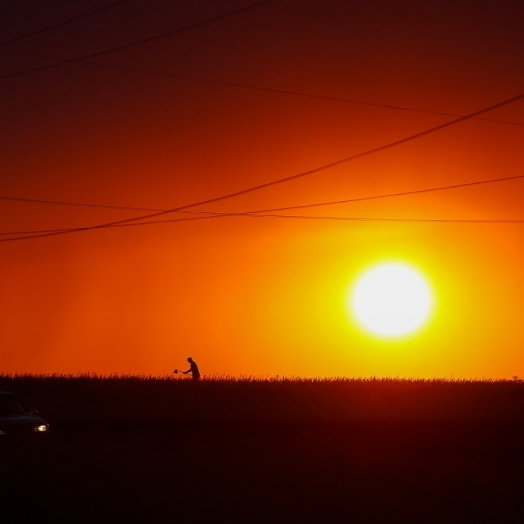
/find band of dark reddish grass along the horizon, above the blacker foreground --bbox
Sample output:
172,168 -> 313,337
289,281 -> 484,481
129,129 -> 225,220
0,374 -> 524,423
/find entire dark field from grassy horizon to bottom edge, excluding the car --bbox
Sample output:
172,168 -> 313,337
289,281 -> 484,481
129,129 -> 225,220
0,375 -> 524,524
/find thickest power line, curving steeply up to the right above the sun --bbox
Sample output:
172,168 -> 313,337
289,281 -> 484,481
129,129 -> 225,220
2,93 -> 524,241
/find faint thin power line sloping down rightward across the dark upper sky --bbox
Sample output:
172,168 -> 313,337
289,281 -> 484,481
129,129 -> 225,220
4,49 -> 524,126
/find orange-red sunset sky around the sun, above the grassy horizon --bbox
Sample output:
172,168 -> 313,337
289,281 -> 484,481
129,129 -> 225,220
0,0 -> 524,378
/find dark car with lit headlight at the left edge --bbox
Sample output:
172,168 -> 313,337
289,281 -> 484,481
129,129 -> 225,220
0,391 -> 49,439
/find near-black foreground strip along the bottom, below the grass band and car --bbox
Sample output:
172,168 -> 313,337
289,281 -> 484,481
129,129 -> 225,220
0,421 -> 524,524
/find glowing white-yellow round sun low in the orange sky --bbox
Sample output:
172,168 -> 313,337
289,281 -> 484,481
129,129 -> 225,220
347,262 -> 433,338
